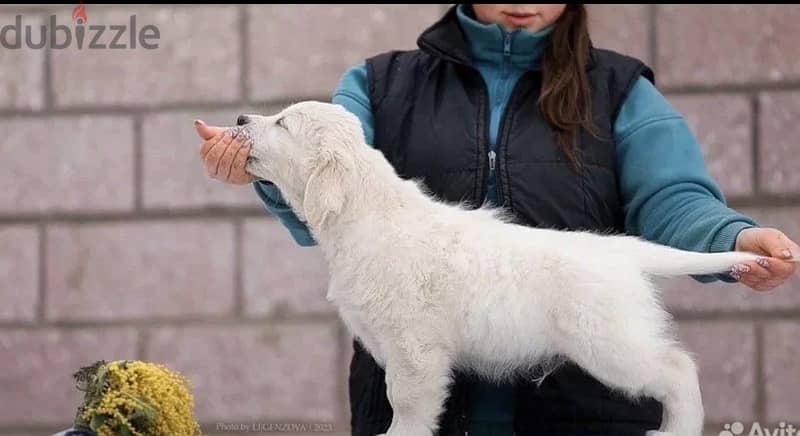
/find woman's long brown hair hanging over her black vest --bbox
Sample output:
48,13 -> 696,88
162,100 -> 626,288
538,4 -> 596,168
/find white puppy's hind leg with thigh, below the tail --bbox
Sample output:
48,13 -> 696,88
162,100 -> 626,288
559,290 -> 703,436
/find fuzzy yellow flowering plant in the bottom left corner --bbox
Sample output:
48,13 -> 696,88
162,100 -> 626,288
74,360 -> 200,436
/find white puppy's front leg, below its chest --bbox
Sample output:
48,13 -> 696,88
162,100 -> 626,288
378,344 -> 451,436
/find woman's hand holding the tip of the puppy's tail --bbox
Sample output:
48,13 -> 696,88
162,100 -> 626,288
731,228 -> 800,291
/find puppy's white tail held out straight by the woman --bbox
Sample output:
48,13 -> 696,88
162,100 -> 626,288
633,240 -> 763,277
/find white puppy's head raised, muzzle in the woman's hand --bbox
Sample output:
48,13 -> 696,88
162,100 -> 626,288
237,101 -> 364,230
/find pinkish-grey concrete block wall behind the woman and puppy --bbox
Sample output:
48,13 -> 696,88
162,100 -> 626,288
0,4 -> 800,436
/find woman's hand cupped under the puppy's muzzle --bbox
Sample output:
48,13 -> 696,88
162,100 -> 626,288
194,120 -> 257,185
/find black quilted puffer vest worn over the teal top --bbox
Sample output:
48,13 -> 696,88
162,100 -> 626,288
349,6 -> 662,436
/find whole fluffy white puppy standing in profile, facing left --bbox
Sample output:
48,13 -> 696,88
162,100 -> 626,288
241,102 -> 759,436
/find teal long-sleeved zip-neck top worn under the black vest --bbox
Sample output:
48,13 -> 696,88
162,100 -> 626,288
255,5 -> 757,426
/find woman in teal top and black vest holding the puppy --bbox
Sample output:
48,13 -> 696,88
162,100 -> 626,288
197,4 -> 800,436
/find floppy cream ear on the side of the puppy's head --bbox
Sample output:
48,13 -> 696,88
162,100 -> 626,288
303,147 -> 352,228
